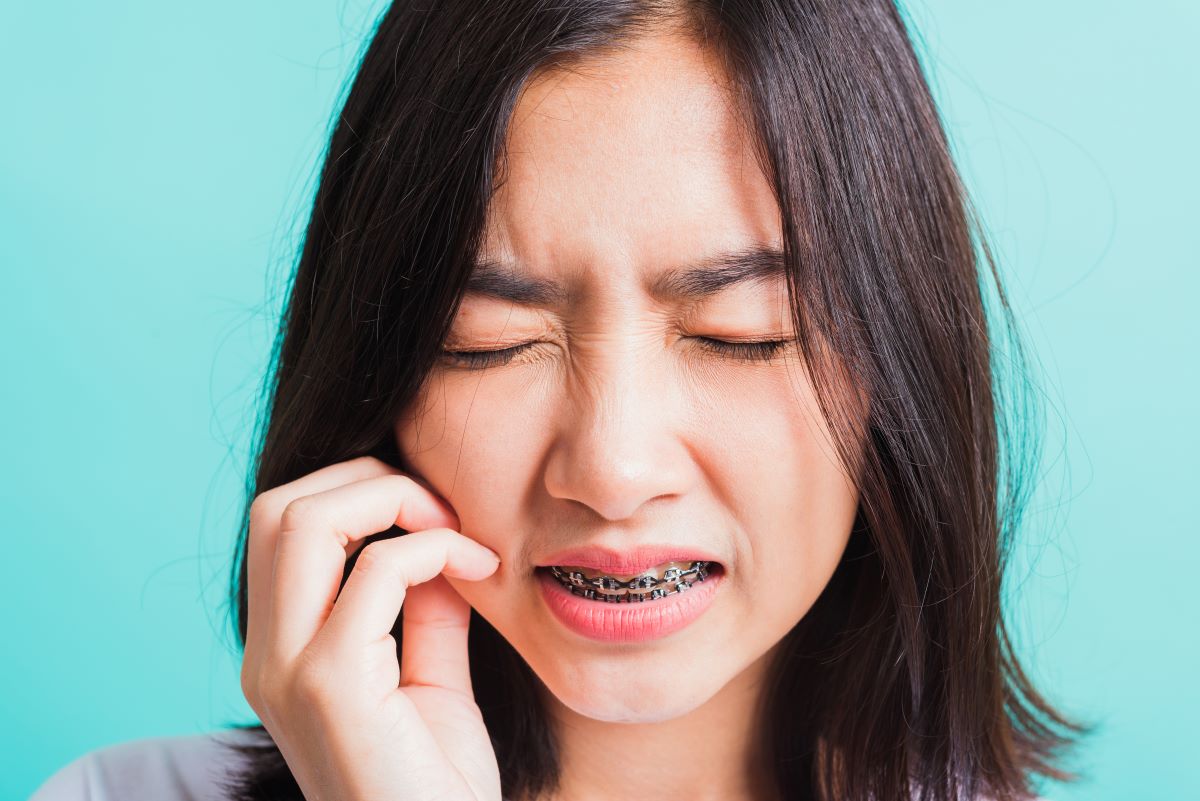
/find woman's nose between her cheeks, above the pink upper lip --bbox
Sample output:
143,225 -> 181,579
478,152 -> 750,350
545,349 -> 696,520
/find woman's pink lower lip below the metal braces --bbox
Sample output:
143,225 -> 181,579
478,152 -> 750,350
535,567 -> 725,643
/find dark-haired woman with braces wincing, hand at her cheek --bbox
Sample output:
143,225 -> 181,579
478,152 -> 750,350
35,0 -> 1084,801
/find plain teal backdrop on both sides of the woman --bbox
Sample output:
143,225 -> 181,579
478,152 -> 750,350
0,0 -> 1200,801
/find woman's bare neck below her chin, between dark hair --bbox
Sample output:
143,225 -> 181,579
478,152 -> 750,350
530,646 -> 778,801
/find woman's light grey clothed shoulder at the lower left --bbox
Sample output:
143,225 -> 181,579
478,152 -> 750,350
29,729 -> 261,801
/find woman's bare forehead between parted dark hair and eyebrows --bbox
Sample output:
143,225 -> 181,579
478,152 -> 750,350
480,27 -> 780,299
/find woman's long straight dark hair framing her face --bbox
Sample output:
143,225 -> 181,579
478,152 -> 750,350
223,0 -> 1087,801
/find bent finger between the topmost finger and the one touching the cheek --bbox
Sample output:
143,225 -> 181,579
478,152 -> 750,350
268,475 -> 466,661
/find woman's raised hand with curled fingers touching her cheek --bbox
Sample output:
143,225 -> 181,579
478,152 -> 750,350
241,457 -> 500,801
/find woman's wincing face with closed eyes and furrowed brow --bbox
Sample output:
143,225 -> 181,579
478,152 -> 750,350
396,36 -> 857,722
